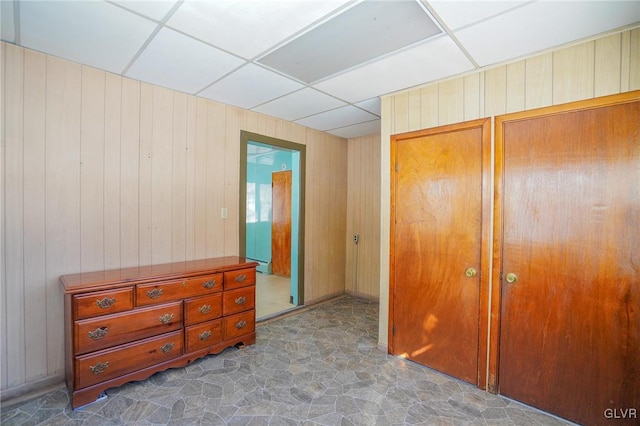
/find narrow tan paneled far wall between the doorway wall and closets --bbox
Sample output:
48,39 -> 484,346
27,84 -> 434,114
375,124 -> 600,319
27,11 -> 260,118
346,135 -> 380,300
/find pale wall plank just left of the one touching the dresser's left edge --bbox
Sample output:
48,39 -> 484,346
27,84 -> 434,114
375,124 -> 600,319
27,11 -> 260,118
22,50 -> 47,381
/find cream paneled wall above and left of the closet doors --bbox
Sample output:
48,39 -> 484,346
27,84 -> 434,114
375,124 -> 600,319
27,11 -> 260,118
378,28 -> 640,348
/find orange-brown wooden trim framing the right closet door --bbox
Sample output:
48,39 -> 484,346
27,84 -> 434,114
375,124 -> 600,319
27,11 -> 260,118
487,90 -> 640,393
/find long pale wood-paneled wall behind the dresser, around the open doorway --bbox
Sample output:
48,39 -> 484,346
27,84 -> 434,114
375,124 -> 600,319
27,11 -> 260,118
0,43 -> 348,398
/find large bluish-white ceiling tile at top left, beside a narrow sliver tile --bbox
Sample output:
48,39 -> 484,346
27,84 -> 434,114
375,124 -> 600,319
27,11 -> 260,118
20,1 -> 156,73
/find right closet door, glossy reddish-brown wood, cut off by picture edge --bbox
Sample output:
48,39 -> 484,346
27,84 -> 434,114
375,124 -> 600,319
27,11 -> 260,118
496,97 -> 640,425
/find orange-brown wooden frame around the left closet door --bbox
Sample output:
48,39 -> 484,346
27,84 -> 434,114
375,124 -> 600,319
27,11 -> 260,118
387,118 -> 493,389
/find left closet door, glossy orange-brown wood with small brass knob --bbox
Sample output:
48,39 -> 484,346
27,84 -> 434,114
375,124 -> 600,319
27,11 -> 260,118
390,121 -> 489,387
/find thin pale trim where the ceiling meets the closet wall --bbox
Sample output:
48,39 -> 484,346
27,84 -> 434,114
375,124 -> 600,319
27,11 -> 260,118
380,21 -> 640,103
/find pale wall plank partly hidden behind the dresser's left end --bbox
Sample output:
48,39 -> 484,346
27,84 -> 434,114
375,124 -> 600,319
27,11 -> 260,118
44,56 -> 82,375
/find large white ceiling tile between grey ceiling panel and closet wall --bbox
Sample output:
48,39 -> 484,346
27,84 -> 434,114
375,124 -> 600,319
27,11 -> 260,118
314,36 -> 473,102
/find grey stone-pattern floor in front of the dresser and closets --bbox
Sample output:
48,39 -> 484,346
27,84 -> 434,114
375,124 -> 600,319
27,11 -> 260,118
0,297 -> 571,426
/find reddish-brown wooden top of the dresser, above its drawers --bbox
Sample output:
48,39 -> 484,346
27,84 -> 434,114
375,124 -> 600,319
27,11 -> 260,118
60,256 -> 258,294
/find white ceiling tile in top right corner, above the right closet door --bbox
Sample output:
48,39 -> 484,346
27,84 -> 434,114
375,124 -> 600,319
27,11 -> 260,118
455,1 -> 640,66
